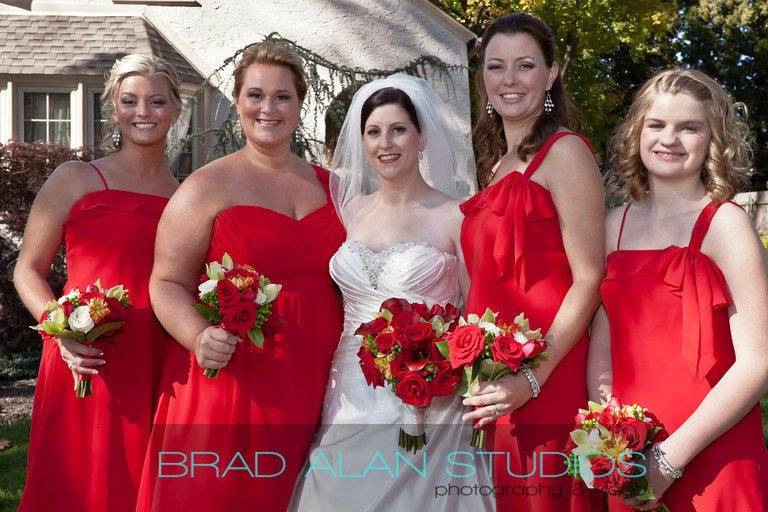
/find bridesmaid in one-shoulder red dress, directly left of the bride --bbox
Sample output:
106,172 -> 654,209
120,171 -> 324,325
137,42 -> 345,512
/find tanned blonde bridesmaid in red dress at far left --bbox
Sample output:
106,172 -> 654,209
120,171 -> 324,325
14,54 -> 181,512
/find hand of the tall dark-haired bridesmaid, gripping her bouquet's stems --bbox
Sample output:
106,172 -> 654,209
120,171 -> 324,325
462,374 -> 531,428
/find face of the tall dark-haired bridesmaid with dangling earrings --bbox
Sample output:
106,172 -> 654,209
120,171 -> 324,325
483,32 -> 559,121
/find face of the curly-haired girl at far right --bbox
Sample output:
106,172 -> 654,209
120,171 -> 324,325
640,93 -> 712,184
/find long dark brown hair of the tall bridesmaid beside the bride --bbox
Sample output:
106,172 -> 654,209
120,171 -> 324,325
473,13 -> 578,185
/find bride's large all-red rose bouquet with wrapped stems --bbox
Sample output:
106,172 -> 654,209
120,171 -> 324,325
355,298 -> 460,452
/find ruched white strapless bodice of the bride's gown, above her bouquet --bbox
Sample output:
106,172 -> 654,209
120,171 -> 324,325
329,240 -> 460,336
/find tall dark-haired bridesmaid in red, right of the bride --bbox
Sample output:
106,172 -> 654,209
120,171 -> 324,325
461,14 -> 603,511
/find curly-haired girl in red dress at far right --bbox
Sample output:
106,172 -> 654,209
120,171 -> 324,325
590,69 -> 768,512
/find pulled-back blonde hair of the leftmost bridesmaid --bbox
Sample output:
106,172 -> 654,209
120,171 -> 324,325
101,53 -> 181,151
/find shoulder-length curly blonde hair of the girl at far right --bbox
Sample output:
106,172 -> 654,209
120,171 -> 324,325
611,68 -> 752,201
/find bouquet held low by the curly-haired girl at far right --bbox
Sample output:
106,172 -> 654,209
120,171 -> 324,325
565,396 -> 669,512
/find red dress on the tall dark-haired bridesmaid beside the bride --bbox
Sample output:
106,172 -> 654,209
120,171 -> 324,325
461,131 -> 601,511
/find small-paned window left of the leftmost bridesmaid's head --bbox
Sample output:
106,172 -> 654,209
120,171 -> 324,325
22,91 -> 72,146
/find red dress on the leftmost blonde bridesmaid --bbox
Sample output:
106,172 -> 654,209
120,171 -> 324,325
19,164 -> 170,512
